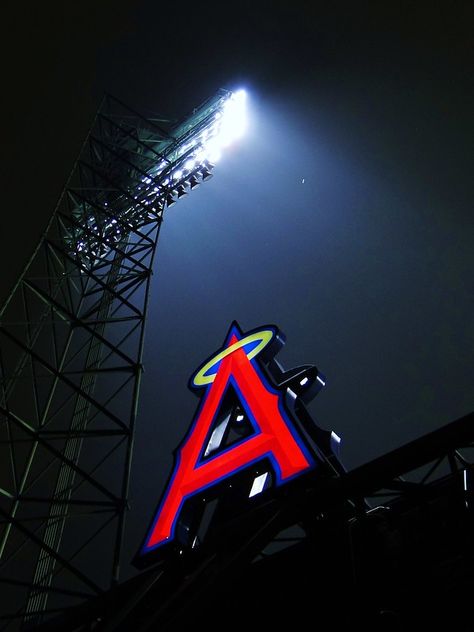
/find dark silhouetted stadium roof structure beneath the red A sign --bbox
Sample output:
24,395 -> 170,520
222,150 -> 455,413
28,414 -> 474,632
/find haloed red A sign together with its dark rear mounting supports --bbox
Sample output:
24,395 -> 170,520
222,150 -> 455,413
136,322 -> 335,564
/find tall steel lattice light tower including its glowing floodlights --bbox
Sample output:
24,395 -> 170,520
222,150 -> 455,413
0,90 -> 246,630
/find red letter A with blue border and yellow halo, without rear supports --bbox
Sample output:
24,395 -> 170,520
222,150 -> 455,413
140,323 -> 323,556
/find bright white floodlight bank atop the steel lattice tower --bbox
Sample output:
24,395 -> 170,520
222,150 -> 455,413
70,90 -> 246,264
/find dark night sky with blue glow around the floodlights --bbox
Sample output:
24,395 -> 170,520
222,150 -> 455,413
0,0 -> 474,576
